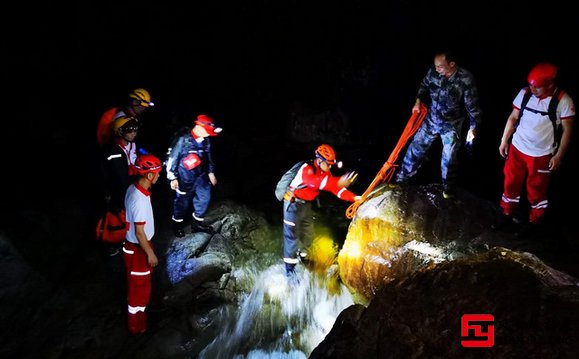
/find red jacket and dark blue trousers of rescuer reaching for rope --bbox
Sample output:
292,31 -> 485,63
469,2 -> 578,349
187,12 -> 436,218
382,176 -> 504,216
283,162 -> 355,274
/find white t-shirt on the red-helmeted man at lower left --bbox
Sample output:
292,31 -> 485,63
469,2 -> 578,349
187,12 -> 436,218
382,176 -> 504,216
125,183 -> 155,244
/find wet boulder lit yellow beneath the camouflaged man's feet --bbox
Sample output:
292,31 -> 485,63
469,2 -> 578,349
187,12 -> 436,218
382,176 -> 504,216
338,185 -> 496,302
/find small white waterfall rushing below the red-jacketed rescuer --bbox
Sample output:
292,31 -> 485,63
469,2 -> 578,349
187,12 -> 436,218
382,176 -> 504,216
198,265 -> 354,359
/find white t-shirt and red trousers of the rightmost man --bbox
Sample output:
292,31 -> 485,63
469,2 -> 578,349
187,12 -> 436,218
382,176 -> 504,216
500,88 -> 575,223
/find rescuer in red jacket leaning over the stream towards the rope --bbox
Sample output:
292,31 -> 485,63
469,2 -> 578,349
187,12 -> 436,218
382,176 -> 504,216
283,144 -> 360,277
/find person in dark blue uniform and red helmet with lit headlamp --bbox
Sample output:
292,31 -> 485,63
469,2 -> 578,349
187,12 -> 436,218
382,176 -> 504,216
166,115 -> 222,238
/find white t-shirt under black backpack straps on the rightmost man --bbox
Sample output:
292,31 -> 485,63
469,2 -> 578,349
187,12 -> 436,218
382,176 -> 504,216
513,88 -> 575,157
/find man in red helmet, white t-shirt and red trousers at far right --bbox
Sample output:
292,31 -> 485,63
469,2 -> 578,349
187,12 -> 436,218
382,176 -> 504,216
492,63 -> 575,238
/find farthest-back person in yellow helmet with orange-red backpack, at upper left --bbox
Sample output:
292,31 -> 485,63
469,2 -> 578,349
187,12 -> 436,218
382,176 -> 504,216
97,88 -> 155,146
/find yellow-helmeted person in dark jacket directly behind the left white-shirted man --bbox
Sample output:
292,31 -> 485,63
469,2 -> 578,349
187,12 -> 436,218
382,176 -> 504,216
103,116 -> 139,257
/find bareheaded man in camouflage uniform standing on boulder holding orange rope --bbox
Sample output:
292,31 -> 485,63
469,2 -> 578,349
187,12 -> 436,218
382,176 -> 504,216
396,52 -> 481,198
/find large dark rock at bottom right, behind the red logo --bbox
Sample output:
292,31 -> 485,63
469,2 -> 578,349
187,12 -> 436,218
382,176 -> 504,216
310,247 -> 579,359
